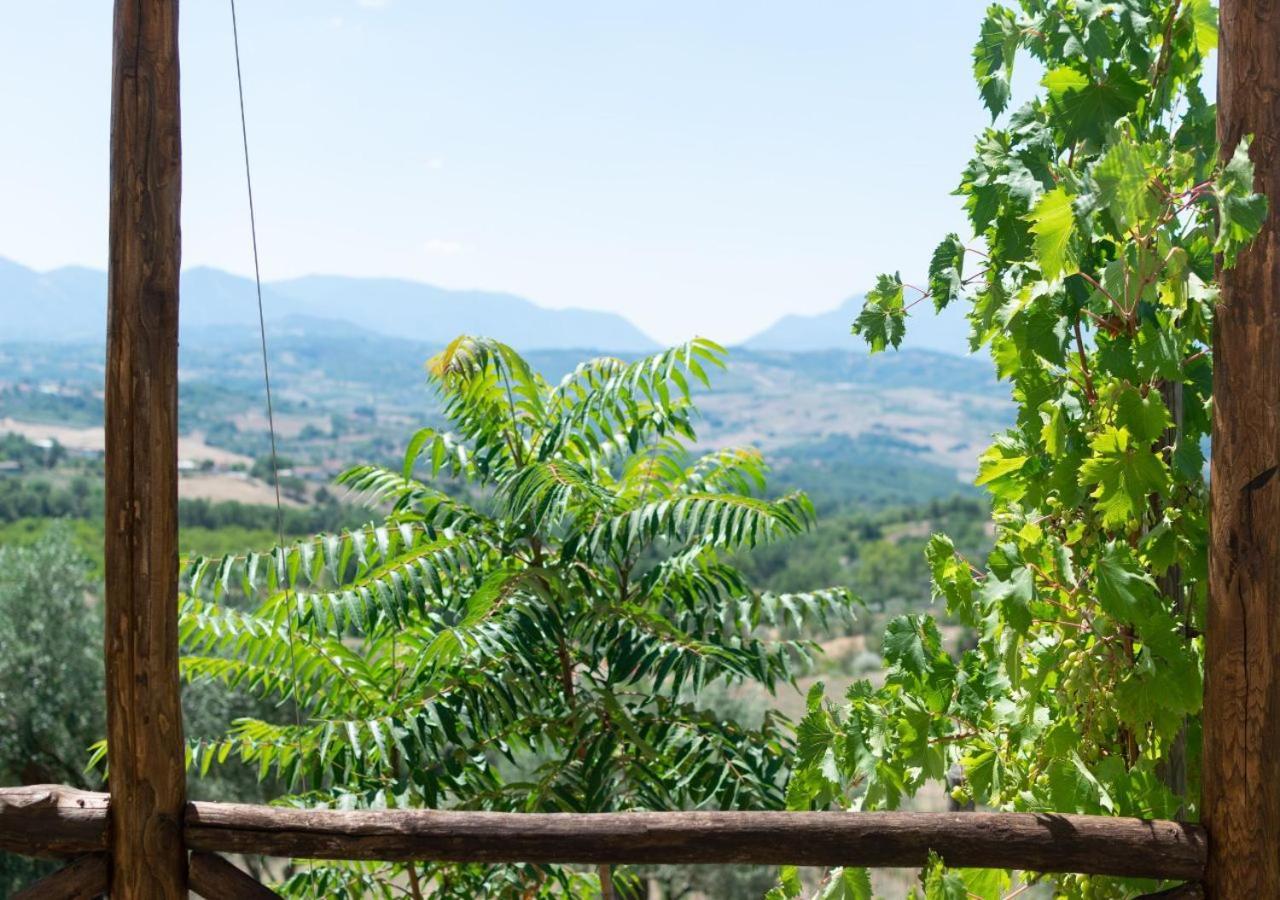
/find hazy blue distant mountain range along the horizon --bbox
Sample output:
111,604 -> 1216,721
0,259 -> 968,353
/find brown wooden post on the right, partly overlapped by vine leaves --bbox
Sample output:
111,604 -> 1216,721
1202,0 -> 1280,900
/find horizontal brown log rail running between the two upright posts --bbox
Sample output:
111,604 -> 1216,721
0,787 -> 1207,880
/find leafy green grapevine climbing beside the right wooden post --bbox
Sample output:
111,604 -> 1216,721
785,0 -> 1266,897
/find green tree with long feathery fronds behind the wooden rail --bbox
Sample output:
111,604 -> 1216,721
172,338 -> 850,897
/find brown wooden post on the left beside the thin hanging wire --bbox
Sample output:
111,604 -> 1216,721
106,0 -> 187,900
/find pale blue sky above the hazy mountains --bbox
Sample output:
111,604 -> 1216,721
0,0 -> 1003,341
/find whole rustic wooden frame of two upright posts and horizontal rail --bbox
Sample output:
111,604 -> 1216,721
0,0 -> 1280,900
